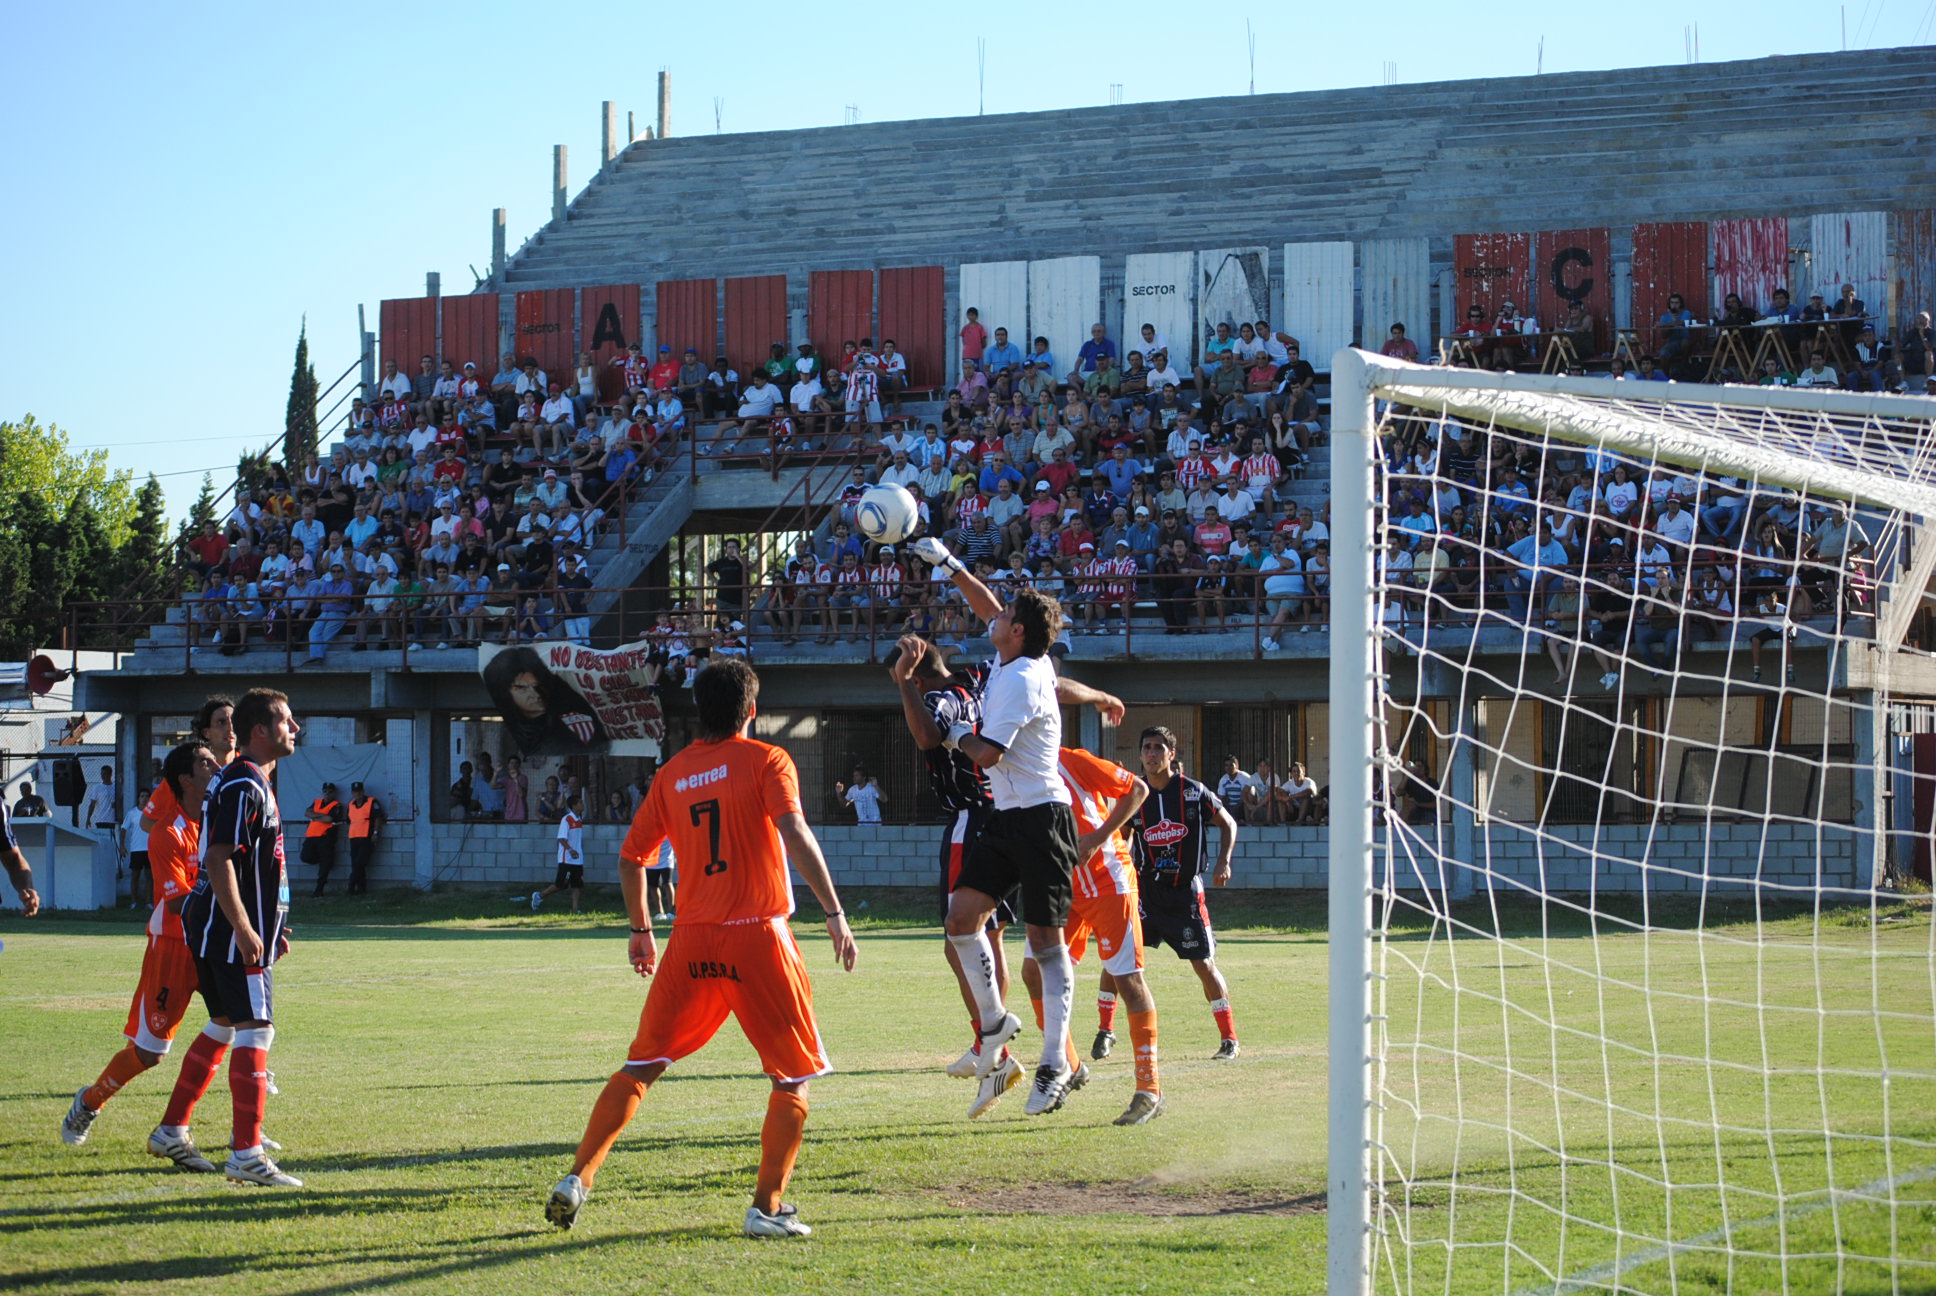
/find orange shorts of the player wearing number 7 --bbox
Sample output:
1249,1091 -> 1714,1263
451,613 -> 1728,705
625,918 -> 832,1081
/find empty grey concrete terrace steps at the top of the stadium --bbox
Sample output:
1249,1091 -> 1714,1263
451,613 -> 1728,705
498,46 -> 1936,296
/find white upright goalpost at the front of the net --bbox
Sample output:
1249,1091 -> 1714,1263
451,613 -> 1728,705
1326,349 -> 1380,1296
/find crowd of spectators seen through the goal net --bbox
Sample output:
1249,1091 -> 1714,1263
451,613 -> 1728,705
1376,409 -> 1872,688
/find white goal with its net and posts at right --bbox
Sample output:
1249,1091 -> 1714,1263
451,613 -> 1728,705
1330,353 -> 1936,1292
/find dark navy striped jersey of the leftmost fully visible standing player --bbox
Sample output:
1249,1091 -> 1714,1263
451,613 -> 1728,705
182,757 -> 288,967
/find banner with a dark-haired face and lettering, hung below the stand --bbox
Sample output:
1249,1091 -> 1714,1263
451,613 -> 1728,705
478,641 -> 666,757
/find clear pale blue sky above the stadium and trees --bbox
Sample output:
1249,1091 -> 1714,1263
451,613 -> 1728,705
0,0 -> 1936,513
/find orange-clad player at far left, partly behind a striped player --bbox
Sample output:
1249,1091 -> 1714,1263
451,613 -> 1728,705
60,742 -> 219,1172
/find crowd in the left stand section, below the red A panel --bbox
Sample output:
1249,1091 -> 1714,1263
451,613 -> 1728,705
182,355 -> 680,663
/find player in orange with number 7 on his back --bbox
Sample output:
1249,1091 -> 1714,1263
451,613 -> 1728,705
544,657 -> 856,1238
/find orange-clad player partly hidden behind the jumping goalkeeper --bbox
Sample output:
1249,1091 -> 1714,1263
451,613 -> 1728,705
1045,748 -> 1164,1126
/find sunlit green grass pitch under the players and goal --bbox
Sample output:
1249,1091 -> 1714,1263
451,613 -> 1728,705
0,893 -> 1936,1294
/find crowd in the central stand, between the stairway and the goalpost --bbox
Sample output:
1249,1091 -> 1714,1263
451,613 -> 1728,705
673,310 -> 1328,647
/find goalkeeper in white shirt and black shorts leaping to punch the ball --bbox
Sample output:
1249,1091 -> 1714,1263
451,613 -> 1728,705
910,537 -> 1078,1116
